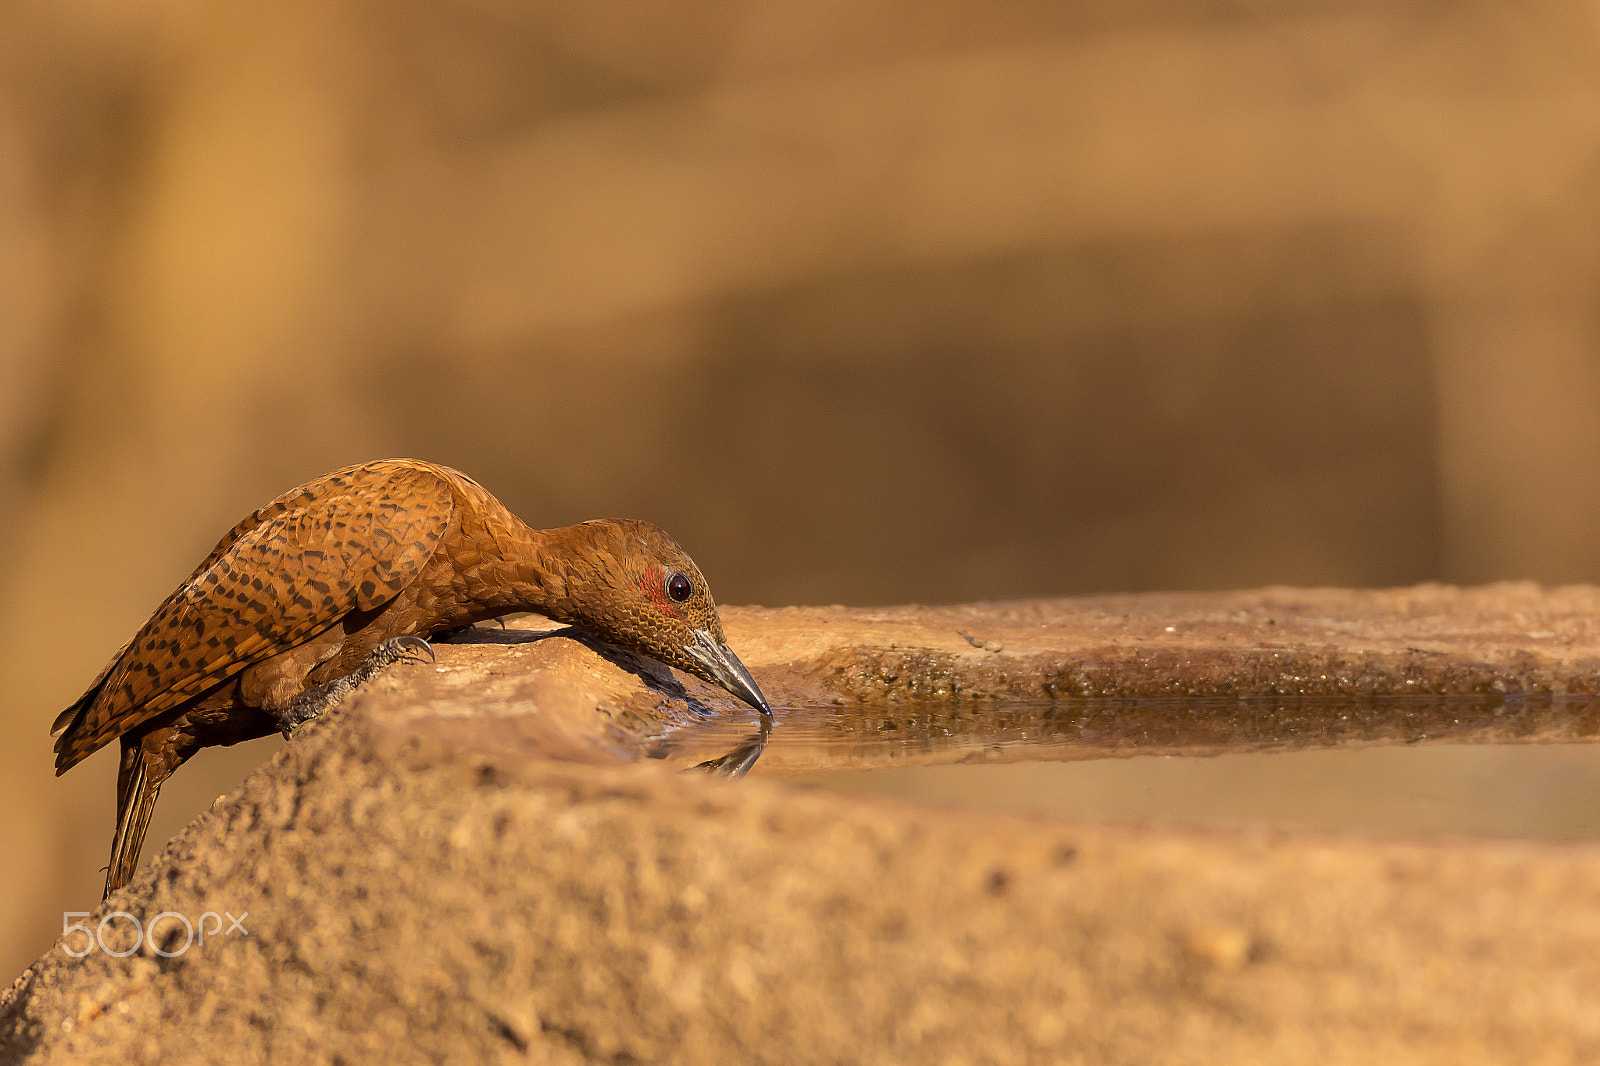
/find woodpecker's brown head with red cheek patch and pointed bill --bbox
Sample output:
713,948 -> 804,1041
552,519 -> 771,714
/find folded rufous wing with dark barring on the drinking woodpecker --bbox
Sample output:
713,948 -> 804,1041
56,463 -> 454,773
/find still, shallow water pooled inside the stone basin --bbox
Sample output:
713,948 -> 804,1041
651,698 -> 1600,840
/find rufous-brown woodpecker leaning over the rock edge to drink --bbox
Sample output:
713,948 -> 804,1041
51,459 -> 770,895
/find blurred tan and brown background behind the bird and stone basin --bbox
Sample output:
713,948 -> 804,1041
0,0 -> 1600,975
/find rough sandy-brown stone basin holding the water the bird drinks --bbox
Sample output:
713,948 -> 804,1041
0,586 -> 1600,1064
